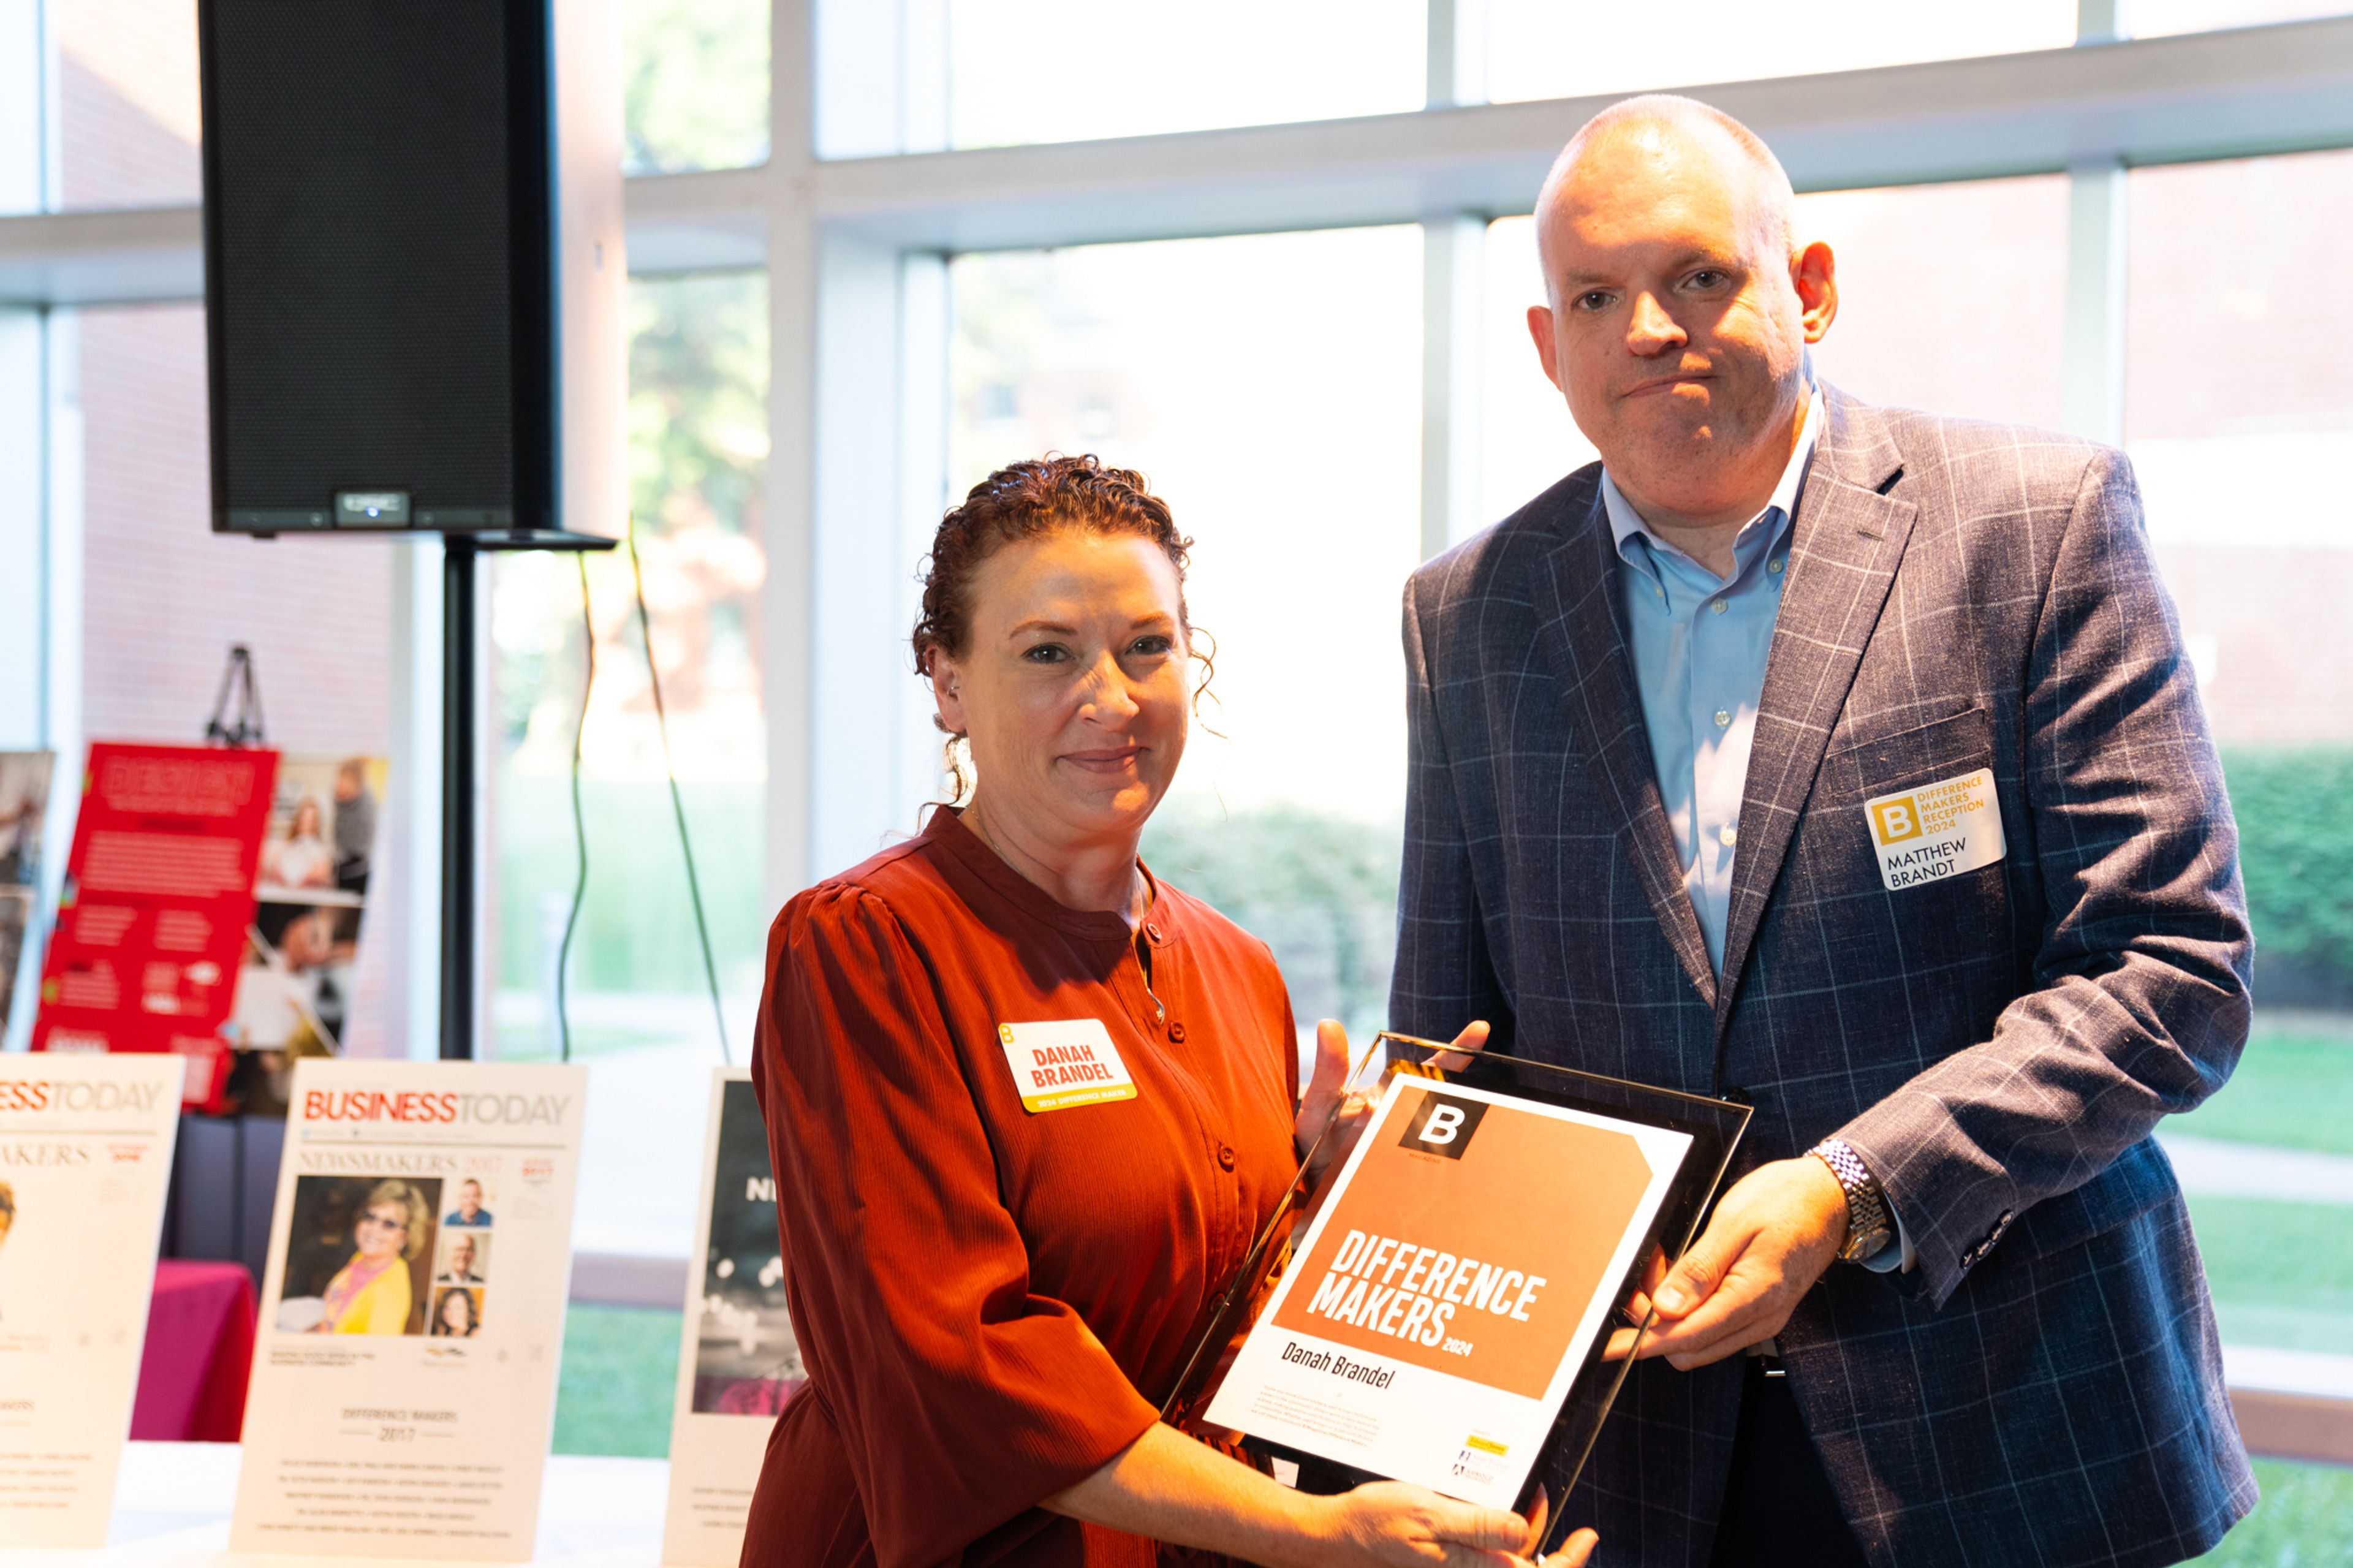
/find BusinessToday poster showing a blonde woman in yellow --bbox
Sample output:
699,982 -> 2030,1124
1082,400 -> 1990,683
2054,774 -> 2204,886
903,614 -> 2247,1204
228,1057 -> 588,1561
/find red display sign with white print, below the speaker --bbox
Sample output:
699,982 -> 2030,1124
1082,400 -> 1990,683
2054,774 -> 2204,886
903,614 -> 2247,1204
33,741 -> 278,1104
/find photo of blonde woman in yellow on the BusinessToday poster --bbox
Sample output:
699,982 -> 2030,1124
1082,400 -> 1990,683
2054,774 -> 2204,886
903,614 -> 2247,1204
271,1177 -> 445,1335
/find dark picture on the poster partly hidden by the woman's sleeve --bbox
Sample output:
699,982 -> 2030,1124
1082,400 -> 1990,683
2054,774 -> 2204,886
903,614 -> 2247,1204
694,1083 -> 809,1417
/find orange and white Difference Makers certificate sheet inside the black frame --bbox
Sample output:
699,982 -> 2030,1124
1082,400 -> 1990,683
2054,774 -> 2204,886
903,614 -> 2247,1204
1207,1076 -> 1692,1507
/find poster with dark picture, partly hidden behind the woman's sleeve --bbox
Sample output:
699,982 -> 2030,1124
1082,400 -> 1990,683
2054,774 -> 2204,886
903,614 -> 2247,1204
661,1067 -> 807,1568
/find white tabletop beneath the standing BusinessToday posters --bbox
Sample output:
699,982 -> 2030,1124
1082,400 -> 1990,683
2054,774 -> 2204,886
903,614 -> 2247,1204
0,1443 -> 670,1568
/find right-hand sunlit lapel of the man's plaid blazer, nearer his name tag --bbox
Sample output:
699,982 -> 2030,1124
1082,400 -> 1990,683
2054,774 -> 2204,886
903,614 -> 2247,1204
1715,388 -> 1913,1031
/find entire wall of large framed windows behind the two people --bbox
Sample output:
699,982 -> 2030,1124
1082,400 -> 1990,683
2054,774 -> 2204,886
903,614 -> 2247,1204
13,0 -> 2353,1525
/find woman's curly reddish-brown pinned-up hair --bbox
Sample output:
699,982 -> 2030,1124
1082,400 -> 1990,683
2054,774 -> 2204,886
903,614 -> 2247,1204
911,452 -> 1210,800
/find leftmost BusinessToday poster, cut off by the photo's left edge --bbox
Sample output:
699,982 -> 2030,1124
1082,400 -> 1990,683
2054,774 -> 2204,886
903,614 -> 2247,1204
0,1053 -> 186,1547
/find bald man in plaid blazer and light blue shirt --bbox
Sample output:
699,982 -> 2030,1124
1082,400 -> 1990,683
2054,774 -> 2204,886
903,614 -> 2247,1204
1390,97 -> 2254,1568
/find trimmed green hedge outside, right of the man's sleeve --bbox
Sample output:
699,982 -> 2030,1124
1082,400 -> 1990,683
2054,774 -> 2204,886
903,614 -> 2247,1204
2224,746 -> 2353,993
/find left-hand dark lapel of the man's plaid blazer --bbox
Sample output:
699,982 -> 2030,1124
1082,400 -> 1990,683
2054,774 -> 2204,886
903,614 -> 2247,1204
1537,485 -> 1715,1008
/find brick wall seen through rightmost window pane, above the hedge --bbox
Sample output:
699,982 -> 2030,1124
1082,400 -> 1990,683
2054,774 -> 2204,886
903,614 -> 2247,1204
2125,151 -> 2353,746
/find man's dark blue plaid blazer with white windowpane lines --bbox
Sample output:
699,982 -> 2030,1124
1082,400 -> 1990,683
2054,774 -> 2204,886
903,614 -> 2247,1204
1390,391 -> 2254,1568
